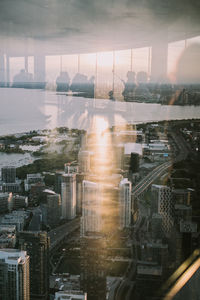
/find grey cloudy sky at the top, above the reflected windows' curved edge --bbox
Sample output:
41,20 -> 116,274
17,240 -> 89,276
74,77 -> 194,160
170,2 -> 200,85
0,0 -> 200,53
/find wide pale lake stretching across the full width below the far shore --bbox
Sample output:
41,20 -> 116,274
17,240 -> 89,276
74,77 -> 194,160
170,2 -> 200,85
0,88 -> 200,135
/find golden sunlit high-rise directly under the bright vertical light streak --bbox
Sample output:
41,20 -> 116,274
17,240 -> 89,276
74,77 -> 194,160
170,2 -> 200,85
81,180 -> 102,236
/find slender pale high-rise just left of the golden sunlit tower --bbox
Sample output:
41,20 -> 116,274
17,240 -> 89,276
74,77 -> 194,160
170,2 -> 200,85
61,174 -> 76,220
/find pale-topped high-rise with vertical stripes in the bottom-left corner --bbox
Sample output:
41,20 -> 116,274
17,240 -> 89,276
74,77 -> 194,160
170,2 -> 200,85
0,249 -> 30,300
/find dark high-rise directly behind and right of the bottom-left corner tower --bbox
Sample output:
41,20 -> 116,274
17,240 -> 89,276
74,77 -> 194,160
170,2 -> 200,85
18,231 -> 50,300
